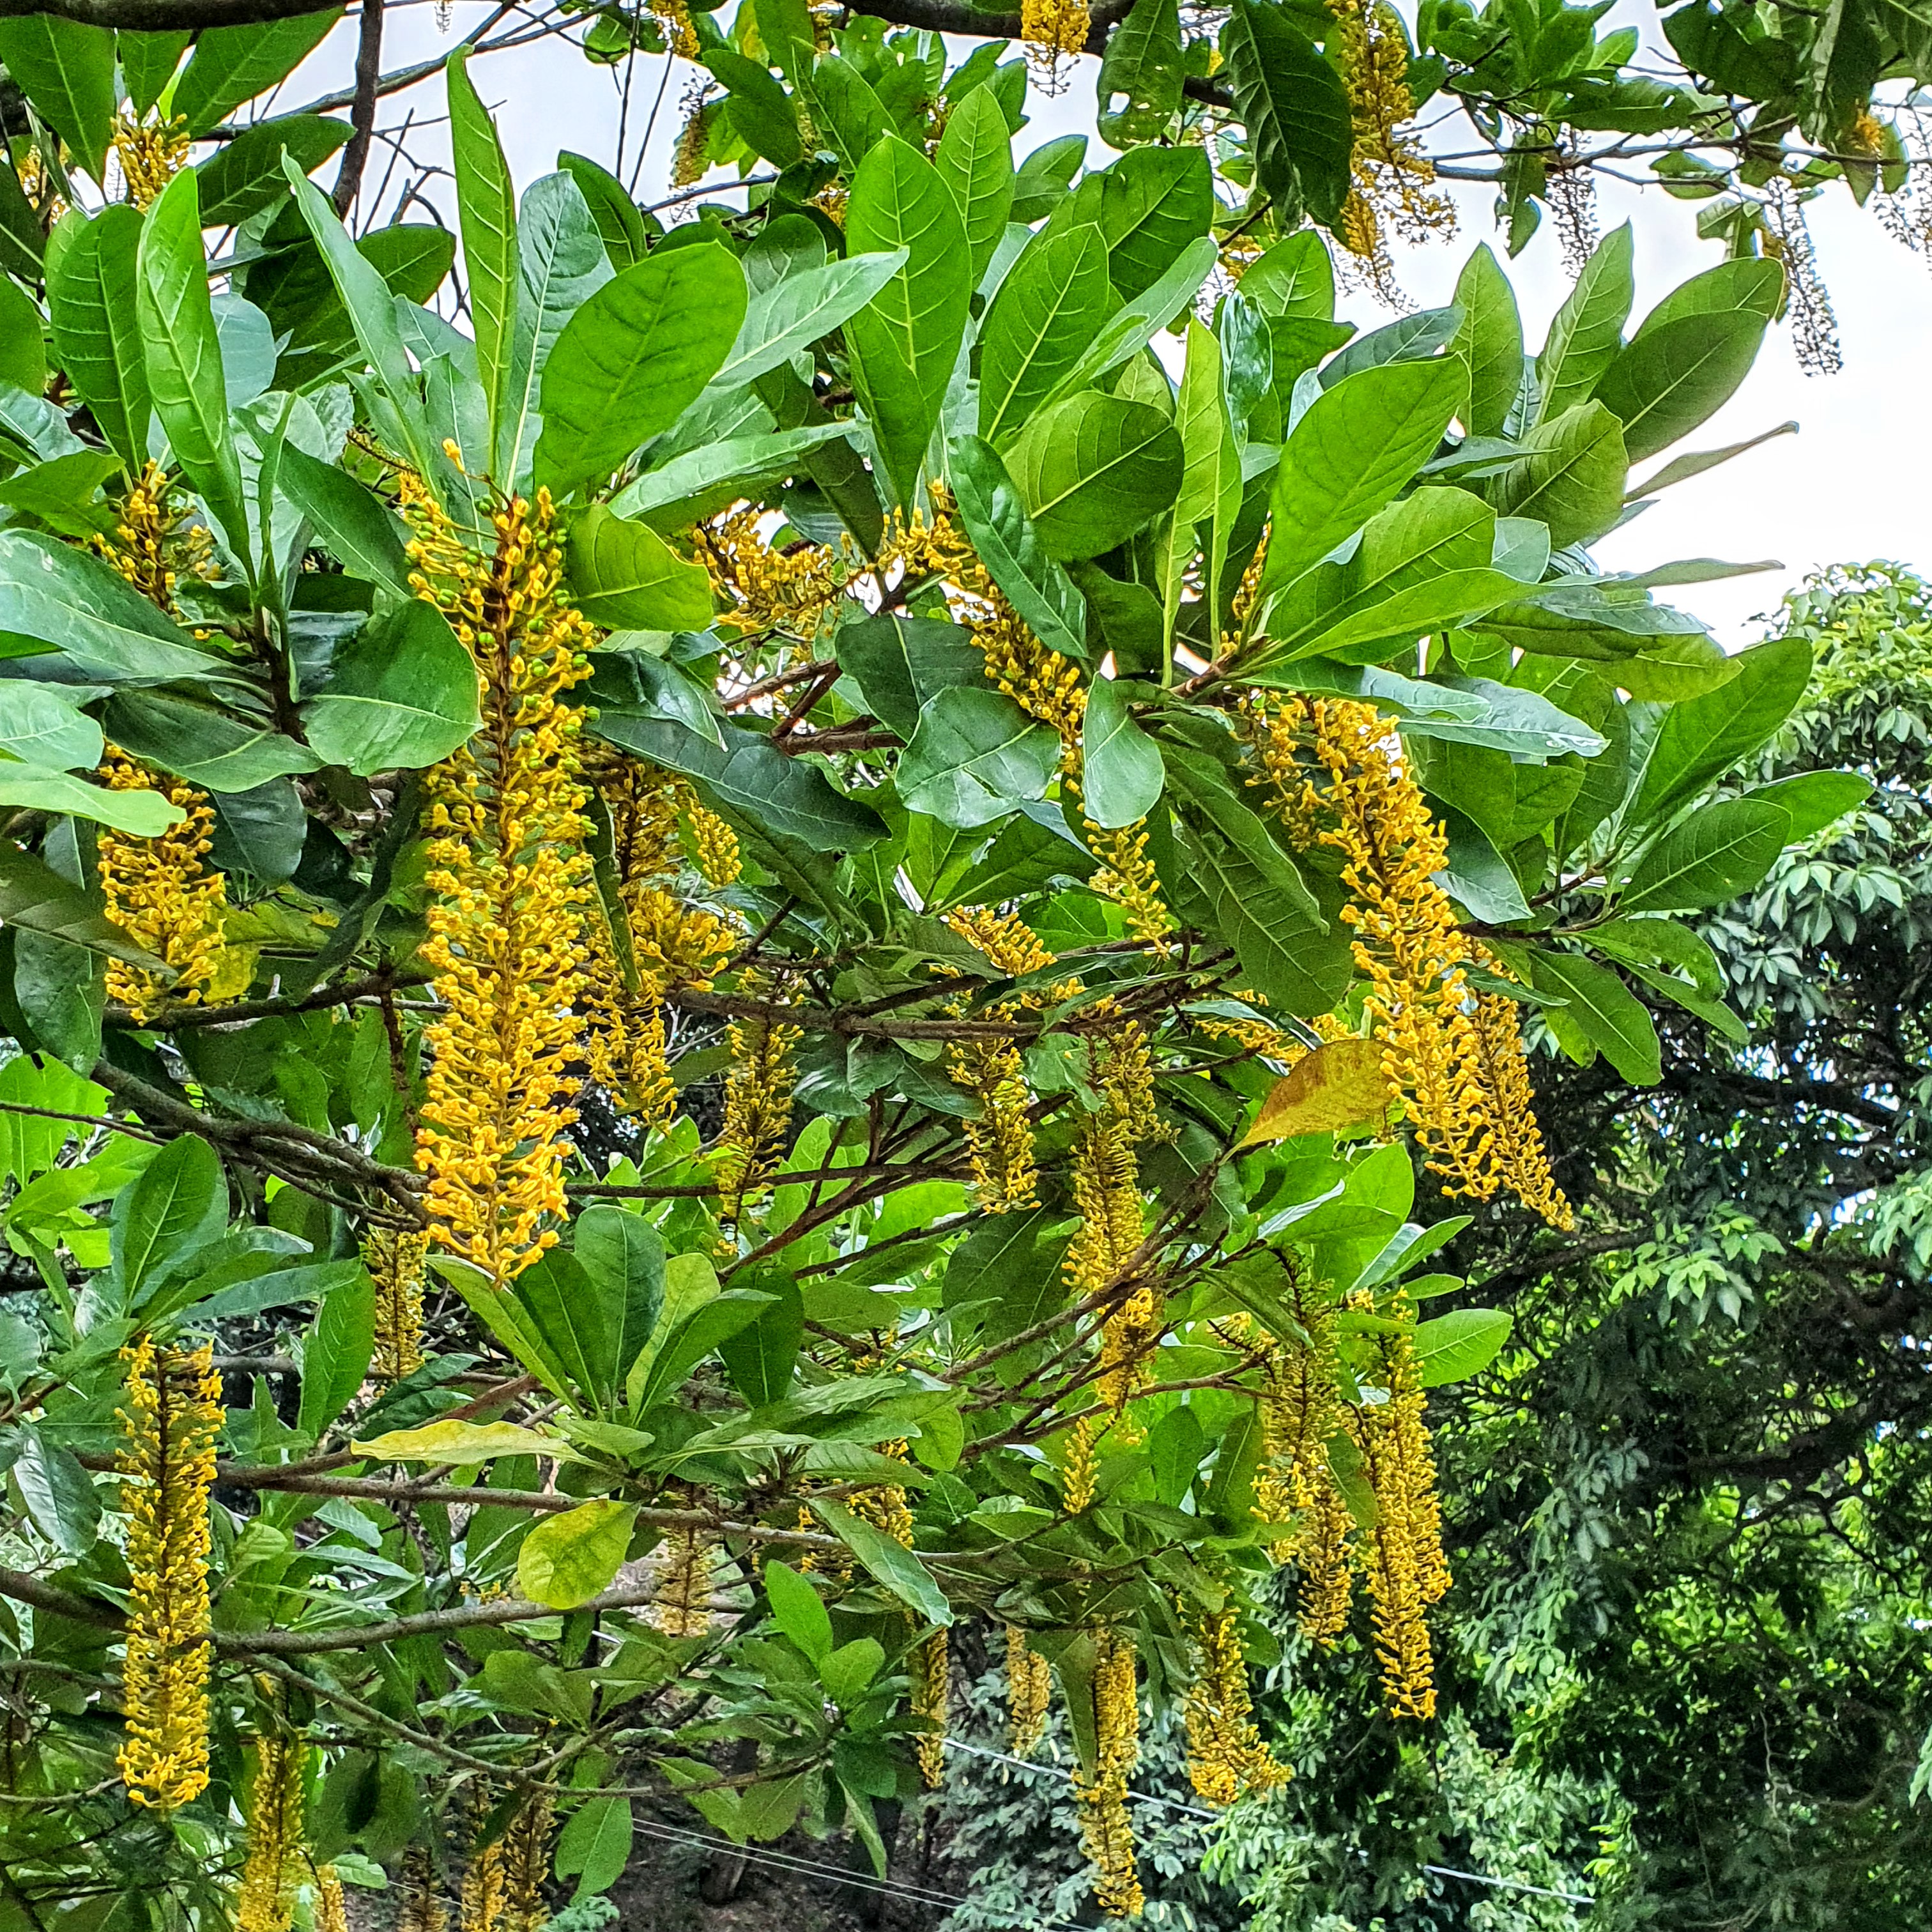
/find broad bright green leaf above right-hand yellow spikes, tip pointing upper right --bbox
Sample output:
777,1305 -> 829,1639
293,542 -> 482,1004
1246,359 -> 1460,601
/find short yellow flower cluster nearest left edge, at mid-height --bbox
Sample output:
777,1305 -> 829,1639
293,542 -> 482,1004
95,746 -> 228,1020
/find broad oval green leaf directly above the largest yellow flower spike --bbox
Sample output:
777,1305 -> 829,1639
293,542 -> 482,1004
537,243 -> 746,491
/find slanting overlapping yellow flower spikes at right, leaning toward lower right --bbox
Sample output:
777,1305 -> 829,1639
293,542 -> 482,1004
1248,698 -> 1573,1227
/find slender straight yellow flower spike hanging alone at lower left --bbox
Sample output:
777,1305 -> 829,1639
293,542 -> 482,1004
118,1335 -> 226,1813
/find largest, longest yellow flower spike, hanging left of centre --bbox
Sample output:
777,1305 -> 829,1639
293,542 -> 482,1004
406,491 -> 591,1285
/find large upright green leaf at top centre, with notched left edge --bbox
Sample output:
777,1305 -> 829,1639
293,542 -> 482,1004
847,135 -> 972,506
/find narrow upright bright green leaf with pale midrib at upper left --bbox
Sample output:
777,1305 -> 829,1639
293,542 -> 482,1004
135,172 -> 249,564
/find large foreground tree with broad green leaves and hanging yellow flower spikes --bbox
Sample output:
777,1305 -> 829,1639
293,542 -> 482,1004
0,15 -> 1837,1928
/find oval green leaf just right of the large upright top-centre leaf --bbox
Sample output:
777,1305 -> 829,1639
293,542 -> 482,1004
979,222 -> 1115,448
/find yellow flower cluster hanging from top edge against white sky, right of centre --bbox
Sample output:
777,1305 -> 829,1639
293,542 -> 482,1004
1327,0 -> 1455,307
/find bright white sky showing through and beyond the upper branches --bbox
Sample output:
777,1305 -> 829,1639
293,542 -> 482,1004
274,0 -> 1932,647
